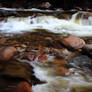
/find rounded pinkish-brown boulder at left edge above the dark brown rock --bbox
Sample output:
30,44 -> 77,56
0,46 -> 17,61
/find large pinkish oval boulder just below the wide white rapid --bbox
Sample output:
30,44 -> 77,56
61,35 -> 85,49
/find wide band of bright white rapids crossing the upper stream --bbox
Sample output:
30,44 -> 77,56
0,13 -> 92,36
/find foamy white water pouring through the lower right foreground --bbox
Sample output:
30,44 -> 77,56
31,63 -> 92,92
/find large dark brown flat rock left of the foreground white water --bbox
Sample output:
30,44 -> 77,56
0,61 -> 33,82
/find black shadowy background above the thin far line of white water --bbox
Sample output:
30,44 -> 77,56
0,0 -> 92,9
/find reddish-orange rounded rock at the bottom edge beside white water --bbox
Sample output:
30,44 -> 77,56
16,82 -> 32,92
